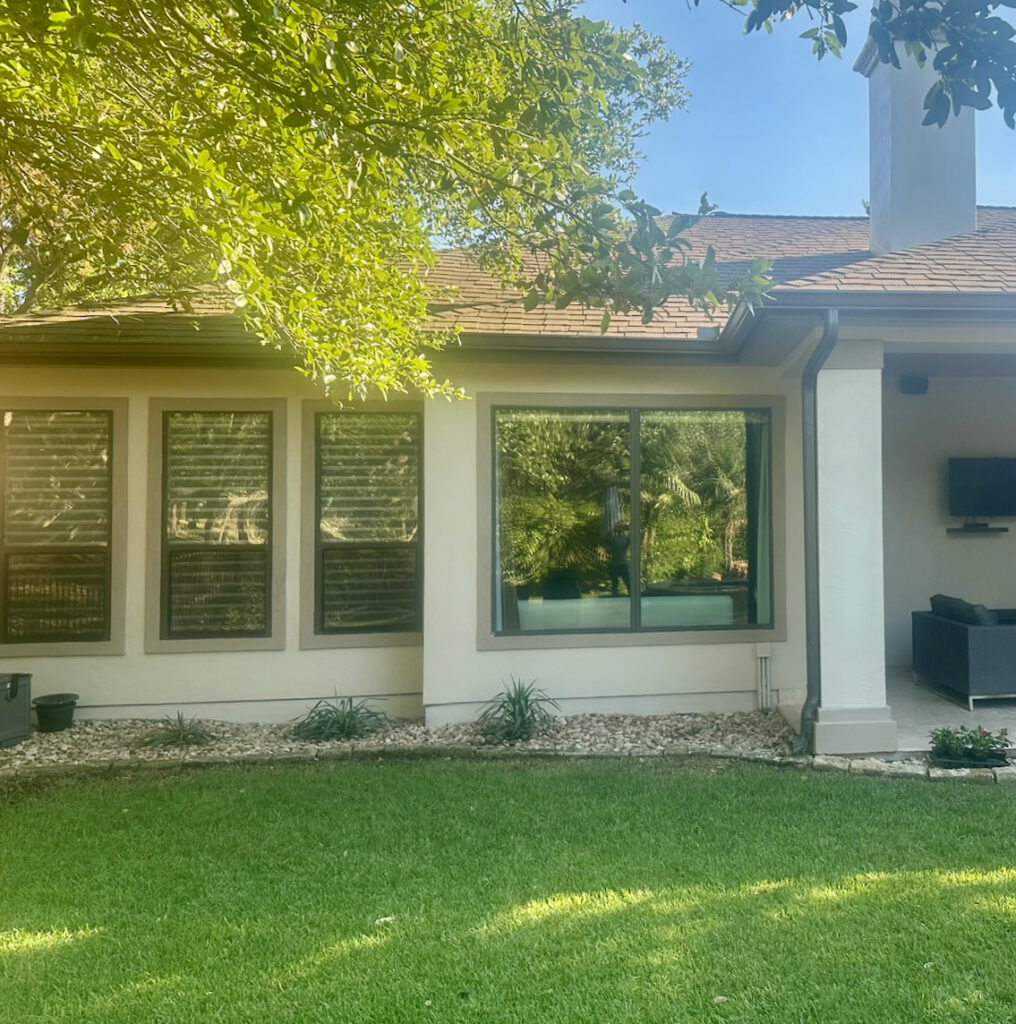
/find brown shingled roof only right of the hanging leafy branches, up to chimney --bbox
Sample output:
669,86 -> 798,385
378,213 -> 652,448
428,207 -> 1016,339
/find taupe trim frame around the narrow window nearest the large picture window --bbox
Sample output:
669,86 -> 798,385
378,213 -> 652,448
300,398 -> 426,650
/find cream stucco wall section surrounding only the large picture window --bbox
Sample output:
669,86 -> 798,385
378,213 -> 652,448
415,359 -> 805,724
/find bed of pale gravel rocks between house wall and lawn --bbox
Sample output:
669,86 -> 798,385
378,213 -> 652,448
0,712 -> 794,773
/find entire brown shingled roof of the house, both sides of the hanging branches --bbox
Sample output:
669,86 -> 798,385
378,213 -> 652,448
0,207 -> 1016,356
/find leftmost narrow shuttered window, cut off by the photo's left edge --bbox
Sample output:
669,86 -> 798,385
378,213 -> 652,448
0,409 -> 113,643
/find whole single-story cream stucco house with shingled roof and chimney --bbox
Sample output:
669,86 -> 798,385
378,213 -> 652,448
0,46 -> 1016,753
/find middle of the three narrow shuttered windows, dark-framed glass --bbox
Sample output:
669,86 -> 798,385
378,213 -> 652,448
162,411 -> 272,639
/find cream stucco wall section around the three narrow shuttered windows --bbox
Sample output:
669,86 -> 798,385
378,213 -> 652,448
0,368 -> 421,721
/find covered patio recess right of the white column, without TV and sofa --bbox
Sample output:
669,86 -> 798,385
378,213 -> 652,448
882,352 -> 1016,751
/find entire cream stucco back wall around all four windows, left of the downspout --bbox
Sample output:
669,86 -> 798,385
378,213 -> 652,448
0,355 -> 805,723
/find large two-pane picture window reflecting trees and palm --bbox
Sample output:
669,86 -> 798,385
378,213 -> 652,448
493,408 -> 772,634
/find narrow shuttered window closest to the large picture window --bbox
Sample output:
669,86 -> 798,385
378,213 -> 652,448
314,413 -> 422,634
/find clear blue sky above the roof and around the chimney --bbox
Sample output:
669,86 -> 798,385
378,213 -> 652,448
583,0 -> 1016,215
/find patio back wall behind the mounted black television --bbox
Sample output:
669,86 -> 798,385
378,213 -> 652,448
883,376 -> 1016,666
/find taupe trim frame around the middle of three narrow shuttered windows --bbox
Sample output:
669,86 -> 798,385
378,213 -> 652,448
144,398 -> 287,654
